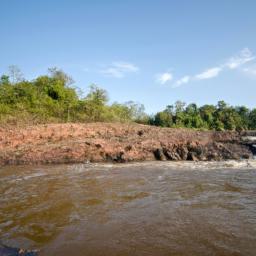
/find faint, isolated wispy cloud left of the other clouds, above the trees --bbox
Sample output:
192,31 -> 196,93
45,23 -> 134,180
100,61 -> 139,78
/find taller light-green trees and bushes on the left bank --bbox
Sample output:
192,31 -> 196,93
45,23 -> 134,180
0,66 -> 146,124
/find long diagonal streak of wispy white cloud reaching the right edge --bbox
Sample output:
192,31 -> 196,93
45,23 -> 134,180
172,48 -> 256,87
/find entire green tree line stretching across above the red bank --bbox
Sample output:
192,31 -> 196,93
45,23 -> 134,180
0,66 -> 256,130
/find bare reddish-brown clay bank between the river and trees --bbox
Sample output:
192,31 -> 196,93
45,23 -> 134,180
0,123 -> 252,165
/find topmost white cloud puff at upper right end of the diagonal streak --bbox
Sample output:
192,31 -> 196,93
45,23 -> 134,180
226,48 -> 255,69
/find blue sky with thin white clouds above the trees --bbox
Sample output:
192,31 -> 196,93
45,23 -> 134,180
0,0 -> 256,113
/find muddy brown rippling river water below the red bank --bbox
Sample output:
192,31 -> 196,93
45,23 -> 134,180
0,161 -> 256,256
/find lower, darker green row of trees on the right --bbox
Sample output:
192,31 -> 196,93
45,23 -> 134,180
149,101 -> 256,131
